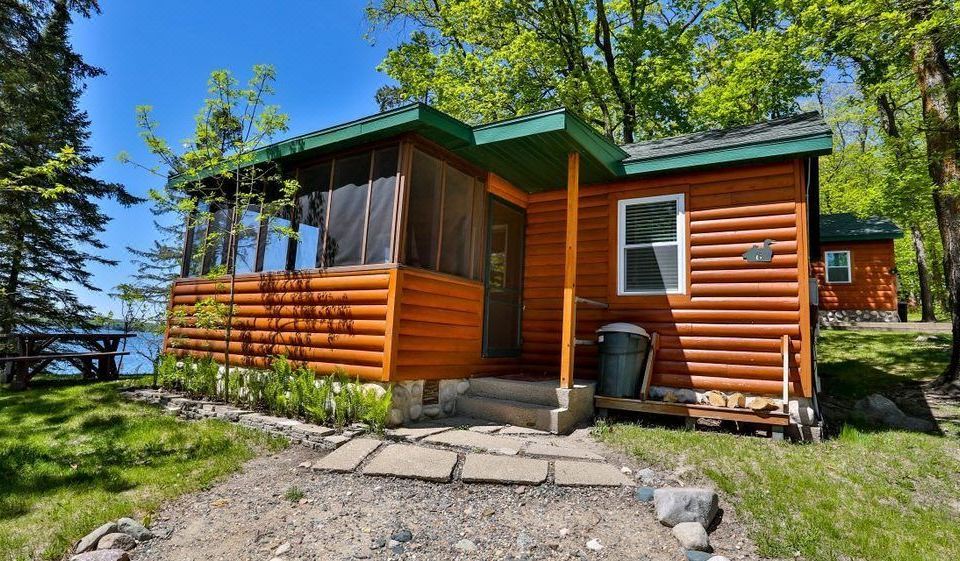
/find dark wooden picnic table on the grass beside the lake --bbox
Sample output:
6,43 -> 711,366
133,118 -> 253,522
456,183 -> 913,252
0,332 -> 136,388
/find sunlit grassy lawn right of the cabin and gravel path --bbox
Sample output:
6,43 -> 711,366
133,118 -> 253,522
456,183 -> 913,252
601,331 -> 960,561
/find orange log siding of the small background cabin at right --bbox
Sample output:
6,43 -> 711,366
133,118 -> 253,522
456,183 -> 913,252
813,240 -> 897,311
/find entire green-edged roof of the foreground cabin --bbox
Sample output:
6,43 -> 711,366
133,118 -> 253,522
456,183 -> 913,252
171,103 -> 832,192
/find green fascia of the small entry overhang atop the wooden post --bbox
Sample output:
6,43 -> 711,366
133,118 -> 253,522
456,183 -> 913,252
473,108 -> 629,176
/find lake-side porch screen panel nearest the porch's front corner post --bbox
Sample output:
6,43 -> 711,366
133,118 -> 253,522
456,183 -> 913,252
364,146 -> 399,264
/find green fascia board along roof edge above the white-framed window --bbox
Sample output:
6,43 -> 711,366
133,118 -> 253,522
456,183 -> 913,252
623,134 -> 833,175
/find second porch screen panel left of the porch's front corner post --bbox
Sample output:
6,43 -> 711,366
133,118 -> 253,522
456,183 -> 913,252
324,152 -> 370,267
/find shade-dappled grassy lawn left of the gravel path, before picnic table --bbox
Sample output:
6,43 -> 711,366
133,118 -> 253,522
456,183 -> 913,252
0,380 -> 283,561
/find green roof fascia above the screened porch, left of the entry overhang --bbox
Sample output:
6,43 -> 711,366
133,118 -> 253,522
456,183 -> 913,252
169,103 -> 473,184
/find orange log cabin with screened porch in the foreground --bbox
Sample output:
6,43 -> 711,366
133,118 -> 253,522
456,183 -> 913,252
166,104 -> 832,435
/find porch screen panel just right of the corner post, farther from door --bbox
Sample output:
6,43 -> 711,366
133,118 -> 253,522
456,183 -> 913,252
404,150 -> 443,269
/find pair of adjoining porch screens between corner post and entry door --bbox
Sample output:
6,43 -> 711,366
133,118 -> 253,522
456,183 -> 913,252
403,149 -> 484,279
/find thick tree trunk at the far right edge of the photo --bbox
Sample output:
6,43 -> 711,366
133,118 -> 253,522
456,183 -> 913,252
910,0 -> 960,389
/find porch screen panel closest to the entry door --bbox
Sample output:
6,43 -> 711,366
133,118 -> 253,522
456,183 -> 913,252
440,165 -> 476,277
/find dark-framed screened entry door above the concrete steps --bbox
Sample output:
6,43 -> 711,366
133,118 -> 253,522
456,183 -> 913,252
483,197 -> 526,357
